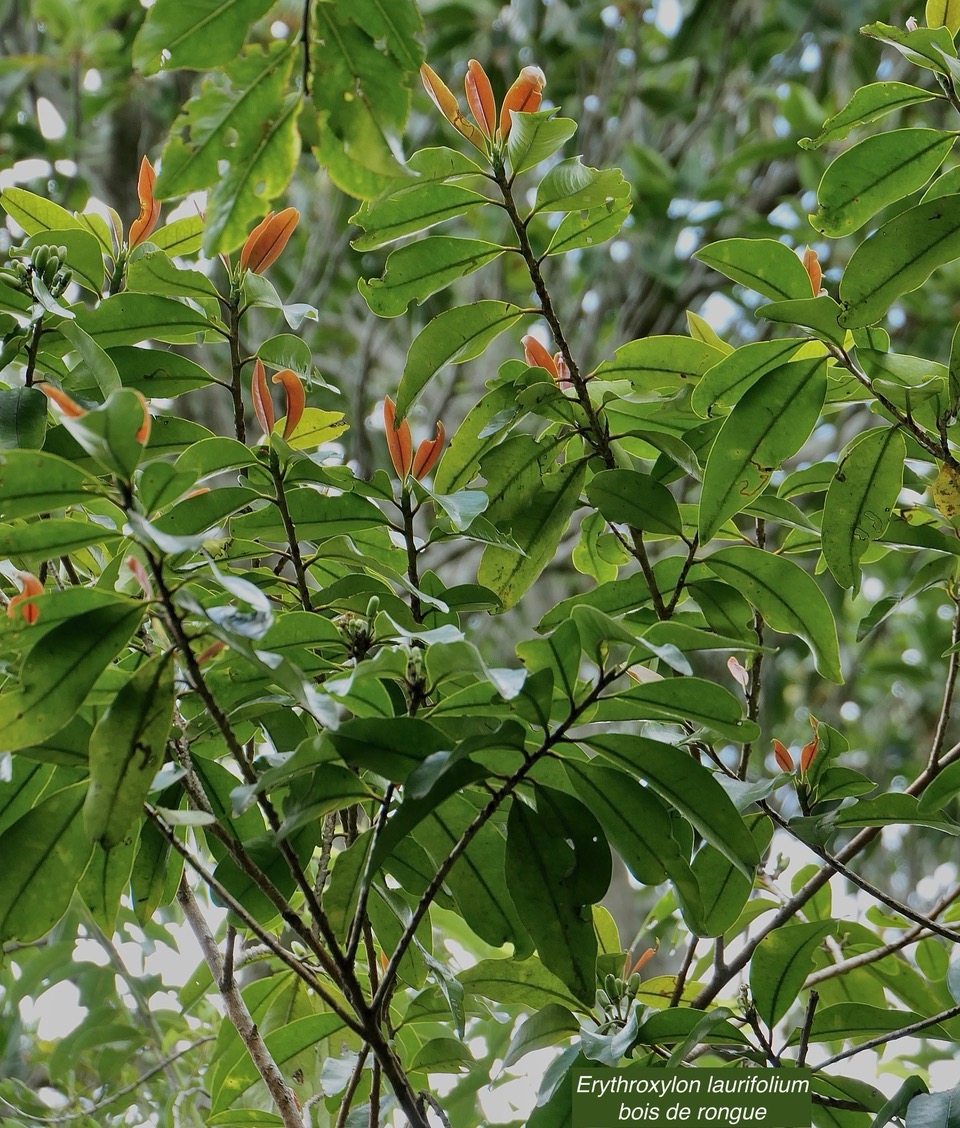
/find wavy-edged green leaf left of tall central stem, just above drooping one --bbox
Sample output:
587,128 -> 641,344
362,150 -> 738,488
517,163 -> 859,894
360,235 -> 503,317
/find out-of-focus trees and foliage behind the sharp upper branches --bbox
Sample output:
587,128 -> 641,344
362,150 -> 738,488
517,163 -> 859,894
0,0 -> 960,1078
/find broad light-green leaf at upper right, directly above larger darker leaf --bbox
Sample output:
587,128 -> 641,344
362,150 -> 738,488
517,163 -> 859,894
810,130 -> 957,239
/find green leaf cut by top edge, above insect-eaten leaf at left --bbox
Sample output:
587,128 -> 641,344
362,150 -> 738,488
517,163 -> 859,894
133,0 -> 273,74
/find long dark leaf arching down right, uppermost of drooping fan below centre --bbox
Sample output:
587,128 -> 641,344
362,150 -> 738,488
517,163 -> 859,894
590,735 -> 760,880
